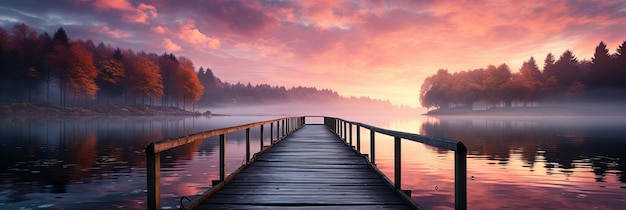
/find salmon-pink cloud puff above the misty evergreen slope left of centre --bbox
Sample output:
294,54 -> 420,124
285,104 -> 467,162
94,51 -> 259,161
178,19 -> 220,49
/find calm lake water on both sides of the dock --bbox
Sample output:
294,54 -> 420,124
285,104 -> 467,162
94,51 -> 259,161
0,116 -> 626,209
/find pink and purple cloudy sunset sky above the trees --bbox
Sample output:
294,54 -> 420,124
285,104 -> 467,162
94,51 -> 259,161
0,0 -> 626,107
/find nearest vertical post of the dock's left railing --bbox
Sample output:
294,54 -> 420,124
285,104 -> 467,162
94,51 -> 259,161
146,143 -> 161,209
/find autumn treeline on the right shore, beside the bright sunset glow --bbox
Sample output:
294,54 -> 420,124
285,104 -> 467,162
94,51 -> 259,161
420,41 -> 626,108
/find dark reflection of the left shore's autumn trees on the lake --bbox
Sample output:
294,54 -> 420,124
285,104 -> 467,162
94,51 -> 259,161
0,117 -> 208,202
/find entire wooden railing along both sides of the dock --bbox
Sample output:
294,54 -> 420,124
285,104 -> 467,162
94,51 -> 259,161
145,116 -> 467,209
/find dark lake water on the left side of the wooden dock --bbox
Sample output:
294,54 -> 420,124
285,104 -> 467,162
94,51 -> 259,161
0,116 -> 274,209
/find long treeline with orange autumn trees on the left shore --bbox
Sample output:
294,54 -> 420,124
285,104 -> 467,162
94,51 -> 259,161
0,23 -> 391,107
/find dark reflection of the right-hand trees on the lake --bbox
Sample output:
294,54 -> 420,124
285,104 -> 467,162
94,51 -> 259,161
421,117 -> 626,183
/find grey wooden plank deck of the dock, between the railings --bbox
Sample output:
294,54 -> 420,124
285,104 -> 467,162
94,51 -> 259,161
196,125 -> 417,209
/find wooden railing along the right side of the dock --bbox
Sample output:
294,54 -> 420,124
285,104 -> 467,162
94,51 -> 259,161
324,117 -> 467,209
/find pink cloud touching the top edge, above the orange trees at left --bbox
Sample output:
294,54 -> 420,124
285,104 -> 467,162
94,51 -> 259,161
93,0 -> 159,24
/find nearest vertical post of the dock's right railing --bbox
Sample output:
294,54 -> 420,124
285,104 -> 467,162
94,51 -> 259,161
454,142 -> 467,209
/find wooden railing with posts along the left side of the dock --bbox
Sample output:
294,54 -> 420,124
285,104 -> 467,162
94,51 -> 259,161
145,116 -> 305,209
